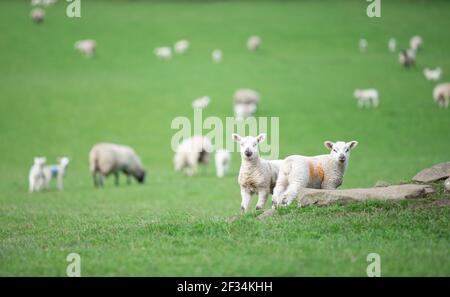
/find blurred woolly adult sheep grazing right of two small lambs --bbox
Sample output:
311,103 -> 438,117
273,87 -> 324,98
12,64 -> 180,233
89,143 -> 145,187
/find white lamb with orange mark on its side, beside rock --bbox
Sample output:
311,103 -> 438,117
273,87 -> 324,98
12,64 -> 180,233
273,140 -> 358,207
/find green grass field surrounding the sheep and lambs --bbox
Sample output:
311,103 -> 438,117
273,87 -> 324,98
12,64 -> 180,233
0,0 -> 450,276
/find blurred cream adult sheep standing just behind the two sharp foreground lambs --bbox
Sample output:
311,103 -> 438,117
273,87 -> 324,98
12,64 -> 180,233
173,135 -> 212,176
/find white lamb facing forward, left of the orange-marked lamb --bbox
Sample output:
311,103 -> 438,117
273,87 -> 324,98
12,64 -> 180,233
232,133 -> 282,214
